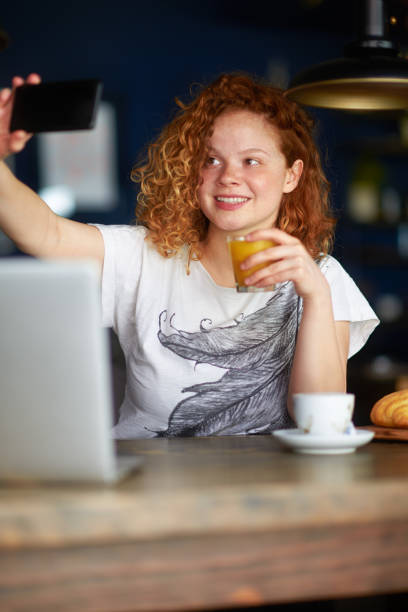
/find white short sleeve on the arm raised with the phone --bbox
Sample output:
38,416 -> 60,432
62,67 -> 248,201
89,224 -> 146,329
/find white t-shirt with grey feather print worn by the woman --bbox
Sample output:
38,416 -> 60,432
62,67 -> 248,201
97,225 -> 379,438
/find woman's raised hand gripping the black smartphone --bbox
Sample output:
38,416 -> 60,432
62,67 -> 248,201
0,73 -> 41,159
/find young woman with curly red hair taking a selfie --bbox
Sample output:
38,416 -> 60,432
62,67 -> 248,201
0,74 -> 378,438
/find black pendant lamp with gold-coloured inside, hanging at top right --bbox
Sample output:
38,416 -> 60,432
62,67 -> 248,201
286,0 -> 408,111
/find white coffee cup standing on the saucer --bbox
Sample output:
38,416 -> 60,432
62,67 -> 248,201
293,393 -> 355,436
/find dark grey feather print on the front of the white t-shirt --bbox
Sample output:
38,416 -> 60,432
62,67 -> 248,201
157,282 -> 302,436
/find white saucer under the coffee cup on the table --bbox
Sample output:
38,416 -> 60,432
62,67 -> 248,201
272,429 -> 374,455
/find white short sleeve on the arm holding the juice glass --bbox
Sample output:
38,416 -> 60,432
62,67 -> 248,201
320,255 -> 380,357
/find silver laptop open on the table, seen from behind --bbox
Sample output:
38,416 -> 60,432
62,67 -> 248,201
0,257 -> 141,483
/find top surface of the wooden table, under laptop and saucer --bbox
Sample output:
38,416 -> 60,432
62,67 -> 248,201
0,436 -> 408,548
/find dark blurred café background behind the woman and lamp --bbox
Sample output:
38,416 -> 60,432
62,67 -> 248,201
0,0 -> 408,424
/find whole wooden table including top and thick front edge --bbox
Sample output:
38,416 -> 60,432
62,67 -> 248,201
0,436 -> 408,612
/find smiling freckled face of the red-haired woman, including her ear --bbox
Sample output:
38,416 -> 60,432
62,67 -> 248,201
198,109 -> 303,234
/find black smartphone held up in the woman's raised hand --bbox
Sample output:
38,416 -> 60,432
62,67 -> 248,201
10,79 -> 102,133
